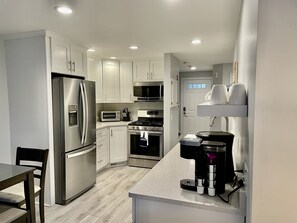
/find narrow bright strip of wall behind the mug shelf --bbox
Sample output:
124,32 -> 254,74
230,0 -> 256,222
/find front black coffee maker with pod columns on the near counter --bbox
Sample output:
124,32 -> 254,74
180,134 -> 226,196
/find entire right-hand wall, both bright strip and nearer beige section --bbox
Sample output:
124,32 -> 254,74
232,0 -> 297,223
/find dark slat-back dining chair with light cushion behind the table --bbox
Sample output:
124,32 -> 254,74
0,147 -> 49,223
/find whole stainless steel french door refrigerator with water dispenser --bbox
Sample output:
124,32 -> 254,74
52,77 -> 96,204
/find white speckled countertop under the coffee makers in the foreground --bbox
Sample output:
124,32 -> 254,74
129,143 -> 246,215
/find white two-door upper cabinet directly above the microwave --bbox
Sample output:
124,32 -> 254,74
133,60 -> 164,82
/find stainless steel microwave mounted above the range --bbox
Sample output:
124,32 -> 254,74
133,82 -> 164,101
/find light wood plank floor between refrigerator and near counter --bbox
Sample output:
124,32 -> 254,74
36,166 -> 149,223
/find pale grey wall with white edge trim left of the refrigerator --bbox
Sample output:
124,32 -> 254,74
5,36 -> 54,205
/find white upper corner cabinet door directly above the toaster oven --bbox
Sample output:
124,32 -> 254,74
102,61 -> 120,102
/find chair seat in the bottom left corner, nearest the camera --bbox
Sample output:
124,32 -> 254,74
0,204 -> 29,223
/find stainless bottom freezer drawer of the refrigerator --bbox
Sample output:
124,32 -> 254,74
65,145 -> 96,203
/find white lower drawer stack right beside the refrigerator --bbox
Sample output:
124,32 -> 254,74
96,128 -> 109,171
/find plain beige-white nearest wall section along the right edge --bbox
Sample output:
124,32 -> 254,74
251,0 -> 297,223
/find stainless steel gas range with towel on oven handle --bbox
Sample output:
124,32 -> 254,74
128,110 -> 163,168
